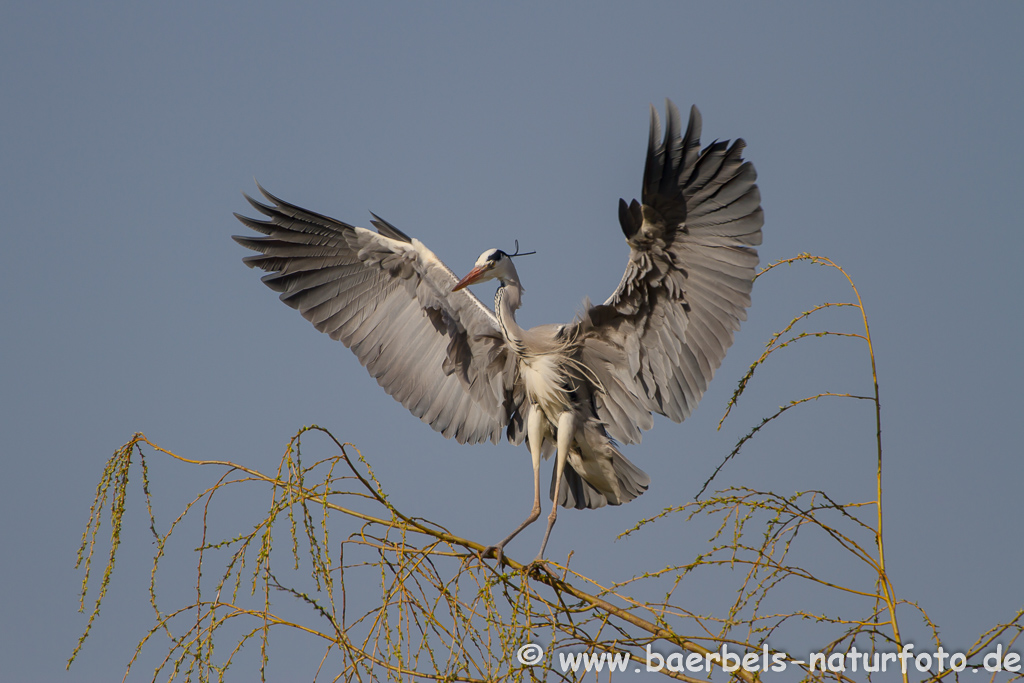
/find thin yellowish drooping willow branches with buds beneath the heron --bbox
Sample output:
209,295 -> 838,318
69,254 -> 1024,682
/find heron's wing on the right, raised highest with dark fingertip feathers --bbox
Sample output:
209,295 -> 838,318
578,101 -> 764,443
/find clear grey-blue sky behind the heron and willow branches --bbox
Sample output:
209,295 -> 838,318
0,2 -> 1024,681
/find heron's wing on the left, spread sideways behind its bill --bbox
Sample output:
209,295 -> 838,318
234,183 -> 516,443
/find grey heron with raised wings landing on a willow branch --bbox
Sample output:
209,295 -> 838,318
234,101 -> 764,562
